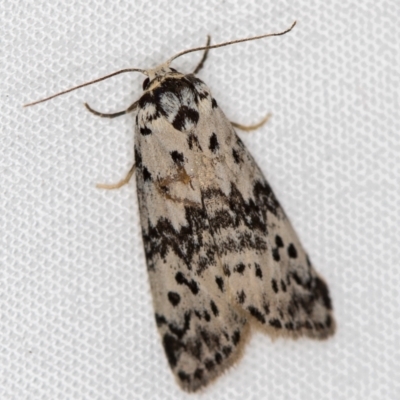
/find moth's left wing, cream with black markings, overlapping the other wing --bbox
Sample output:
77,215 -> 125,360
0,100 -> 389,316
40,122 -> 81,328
135,79 -> 252,392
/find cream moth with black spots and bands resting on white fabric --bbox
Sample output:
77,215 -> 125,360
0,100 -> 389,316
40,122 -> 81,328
25,24 -> 335,392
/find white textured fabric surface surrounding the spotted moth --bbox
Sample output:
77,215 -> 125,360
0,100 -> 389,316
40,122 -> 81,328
0,0 -> 400,400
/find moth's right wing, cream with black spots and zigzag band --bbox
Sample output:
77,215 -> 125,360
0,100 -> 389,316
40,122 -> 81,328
199,101 -> 335,339
